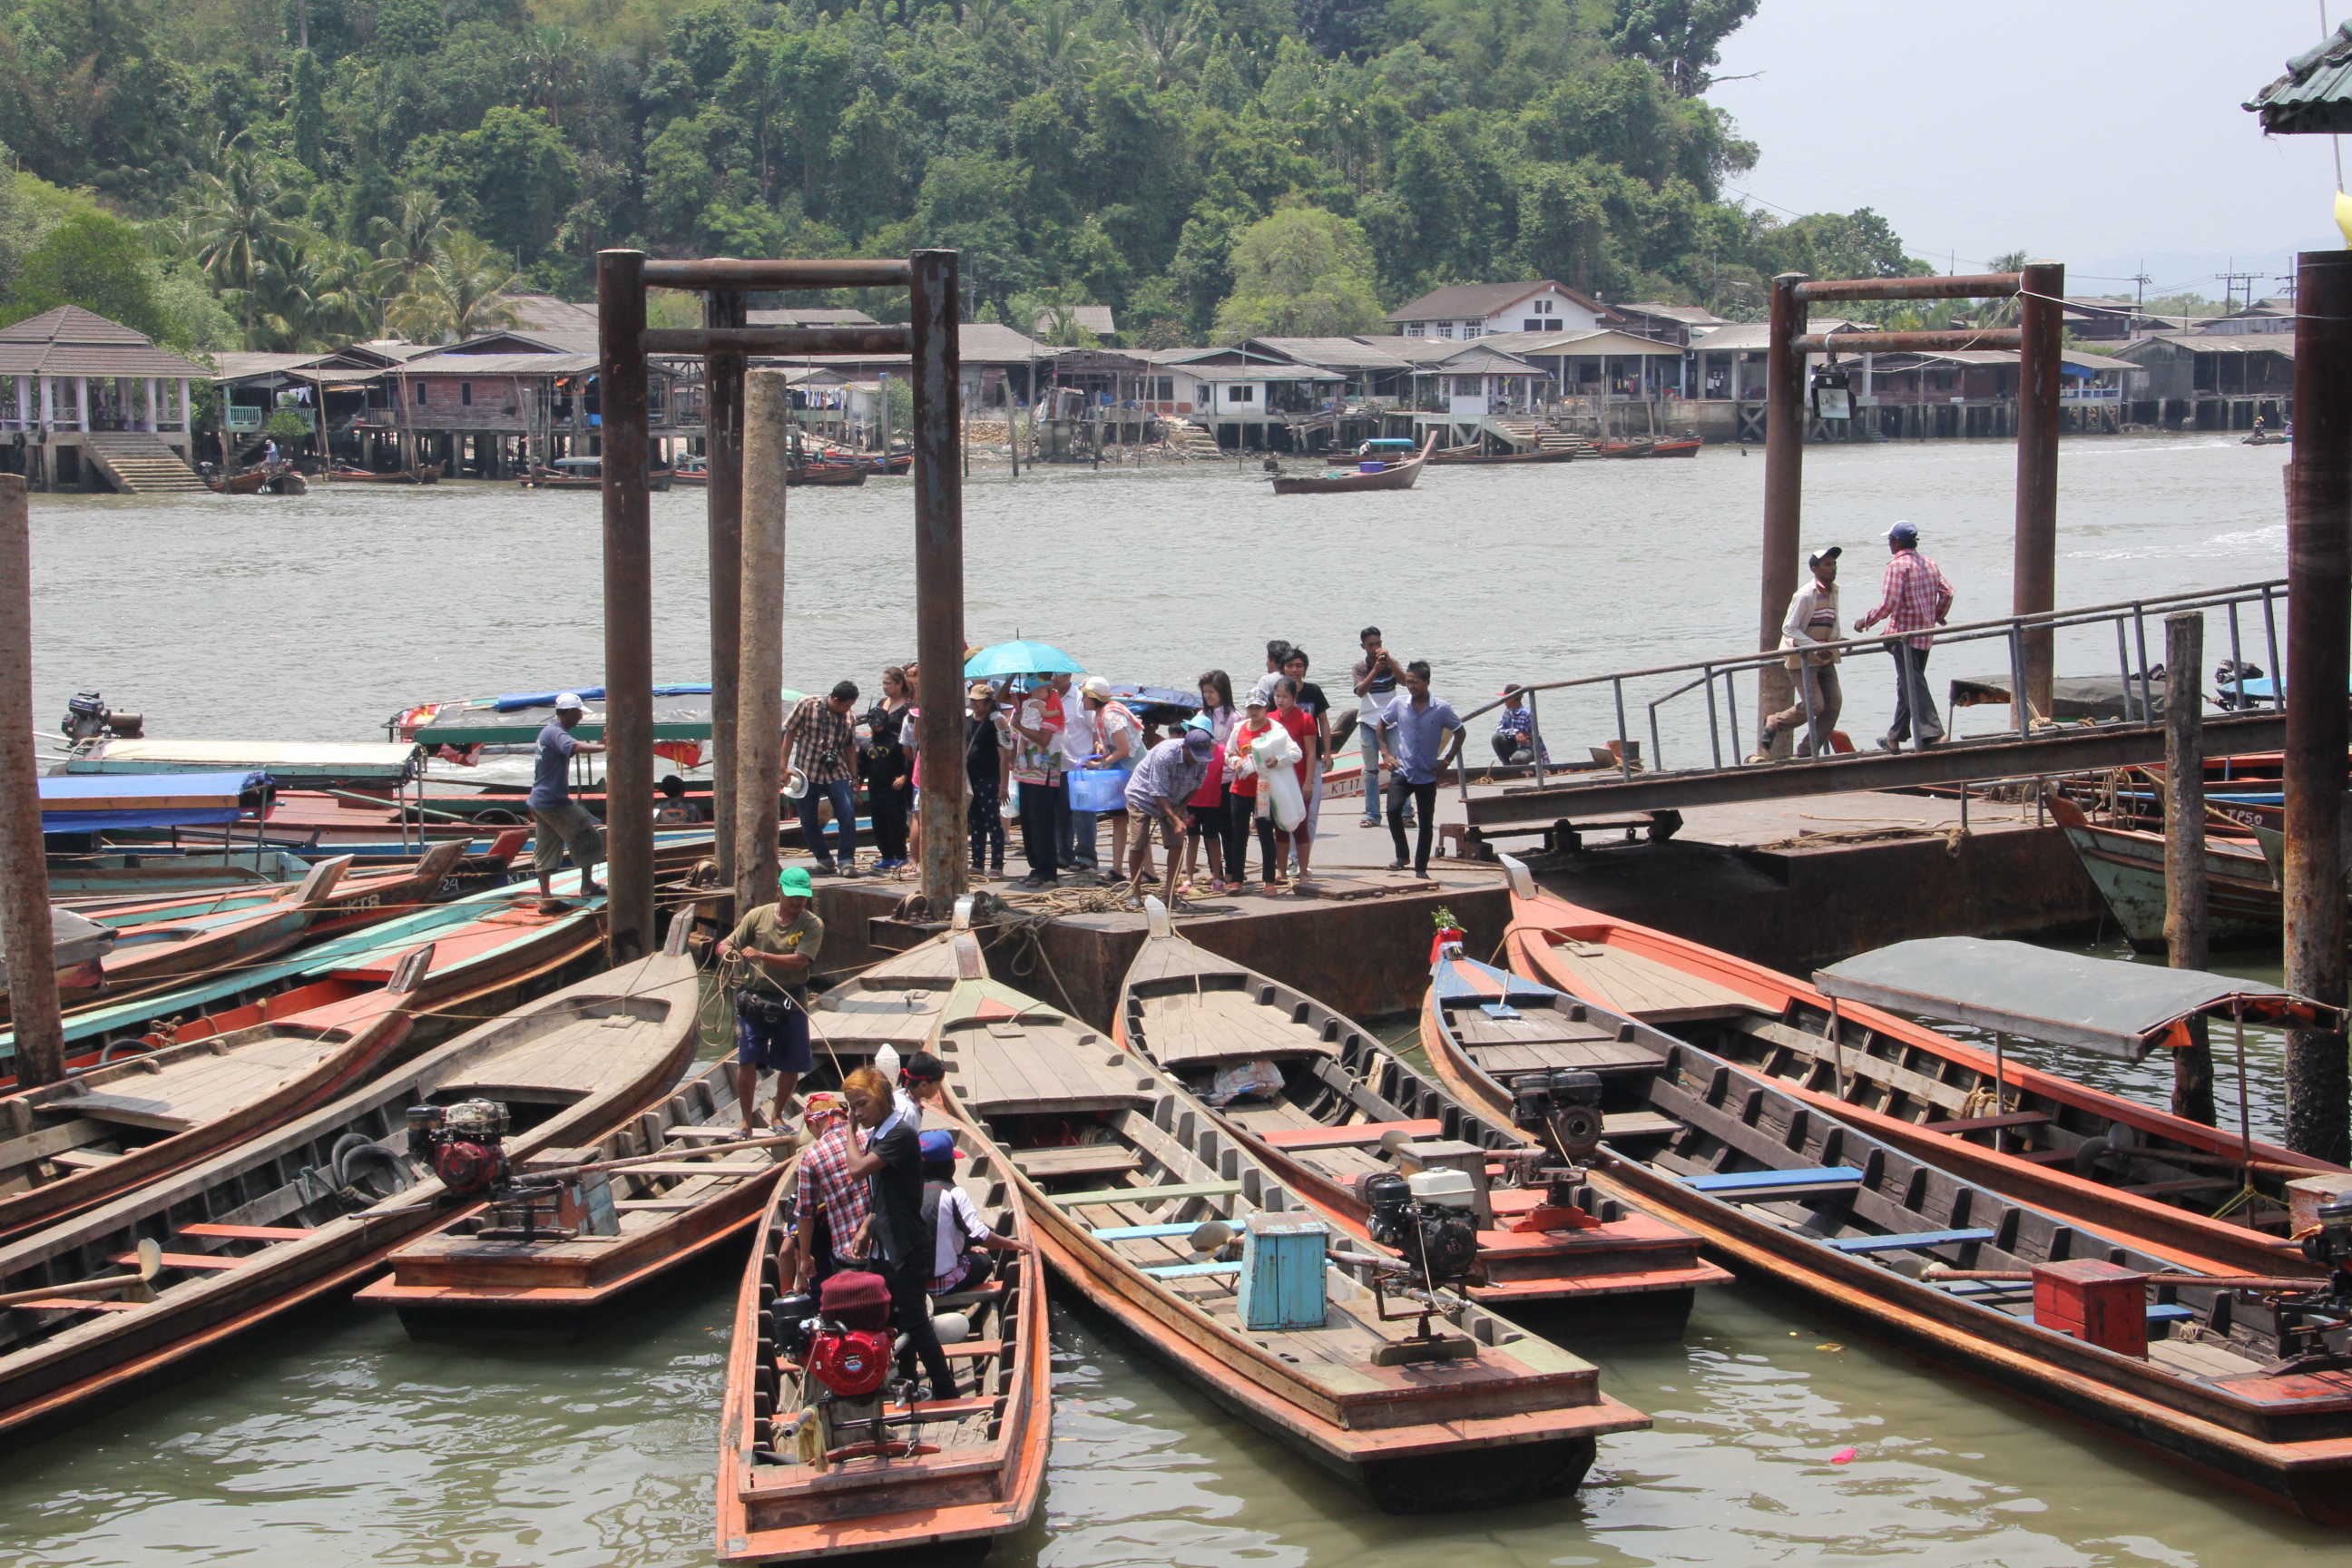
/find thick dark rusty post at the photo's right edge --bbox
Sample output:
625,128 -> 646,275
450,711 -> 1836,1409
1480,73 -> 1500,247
2284,251 -> 2352,1163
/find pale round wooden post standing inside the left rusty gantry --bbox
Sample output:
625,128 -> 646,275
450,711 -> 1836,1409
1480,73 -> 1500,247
734,369 -> 789,916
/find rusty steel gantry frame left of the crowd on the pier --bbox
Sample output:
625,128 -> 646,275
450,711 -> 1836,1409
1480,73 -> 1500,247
597,250 -> 965,964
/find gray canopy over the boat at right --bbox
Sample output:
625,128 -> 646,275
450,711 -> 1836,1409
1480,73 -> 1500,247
1813,936 -> 2336,1060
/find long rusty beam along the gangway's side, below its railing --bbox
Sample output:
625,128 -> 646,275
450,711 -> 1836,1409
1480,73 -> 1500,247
1465,710 -> 2286,828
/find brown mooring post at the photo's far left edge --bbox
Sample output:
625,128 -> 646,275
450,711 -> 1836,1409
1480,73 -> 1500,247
0,473 -> 66,1088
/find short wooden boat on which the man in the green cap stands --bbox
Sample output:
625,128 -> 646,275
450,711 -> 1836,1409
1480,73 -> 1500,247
355,1055 -> 793,1340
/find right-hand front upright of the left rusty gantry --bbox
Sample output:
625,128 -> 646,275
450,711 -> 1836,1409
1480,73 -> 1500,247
908,251 -> 965,919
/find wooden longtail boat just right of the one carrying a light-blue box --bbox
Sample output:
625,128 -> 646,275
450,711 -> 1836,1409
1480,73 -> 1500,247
1112,898 -> 1731,1336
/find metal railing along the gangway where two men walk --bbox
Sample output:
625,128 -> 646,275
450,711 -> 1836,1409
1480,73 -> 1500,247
1458,578 -> 2286,799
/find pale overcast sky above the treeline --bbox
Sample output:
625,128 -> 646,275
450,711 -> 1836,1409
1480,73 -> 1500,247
1708,0 -> 2352,299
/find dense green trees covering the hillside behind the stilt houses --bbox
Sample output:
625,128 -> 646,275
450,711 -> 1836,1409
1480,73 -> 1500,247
0,0 -> 1919,346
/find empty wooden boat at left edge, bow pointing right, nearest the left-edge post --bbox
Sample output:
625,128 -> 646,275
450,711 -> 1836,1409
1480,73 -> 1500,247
0,945 -> 433,1234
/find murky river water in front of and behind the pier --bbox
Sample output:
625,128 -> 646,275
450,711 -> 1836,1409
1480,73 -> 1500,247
0,437 -> 2347,1568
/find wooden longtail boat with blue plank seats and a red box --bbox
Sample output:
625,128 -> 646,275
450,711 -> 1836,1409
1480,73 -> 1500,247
1421,940 -> 2352,1525
